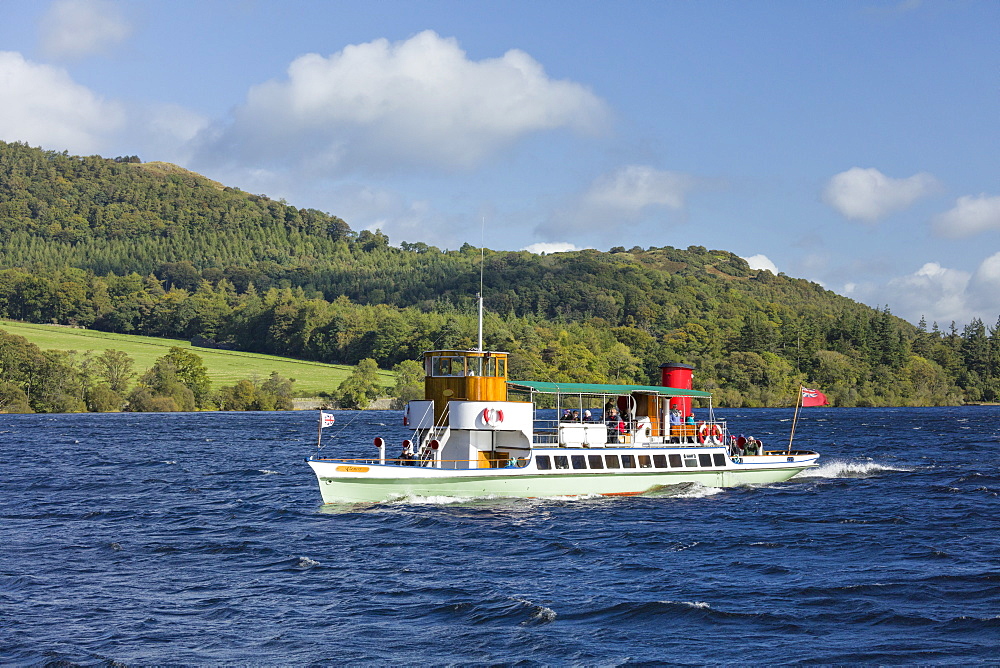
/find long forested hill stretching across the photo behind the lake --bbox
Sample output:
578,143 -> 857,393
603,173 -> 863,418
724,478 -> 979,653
0,142 -> 1000,405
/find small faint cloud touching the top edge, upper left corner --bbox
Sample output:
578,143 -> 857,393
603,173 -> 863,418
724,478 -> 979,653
41,0 -> 132,58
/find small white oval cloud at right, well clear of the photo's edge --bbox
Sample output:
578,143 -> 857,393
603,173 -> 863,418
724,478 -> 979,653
823,167 -> 939,223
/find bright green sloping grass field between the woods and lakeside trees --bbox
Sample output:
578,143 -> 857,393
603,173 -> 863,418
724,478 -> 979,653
0,320 -> 395,397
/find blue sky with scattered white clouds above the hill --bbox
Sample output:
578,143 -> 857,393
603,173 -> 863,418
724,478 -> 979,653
0,0 -> 1000,329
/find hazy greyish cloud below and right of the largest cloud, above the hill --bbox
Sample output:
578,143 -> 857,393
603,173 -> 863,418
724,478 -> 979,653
536,165 -> 697,241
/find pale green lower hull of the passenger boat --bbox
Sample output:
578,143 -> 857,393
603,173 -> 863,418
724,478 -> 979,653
319,466 -> 810,503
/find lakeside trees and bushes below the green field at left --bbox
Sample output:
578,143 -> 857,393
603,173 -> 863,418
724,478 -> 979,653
0,330 -> 293,413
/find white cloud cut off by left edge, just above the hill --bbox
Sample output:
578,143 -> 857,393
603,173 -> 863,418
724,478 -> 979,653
0,51 -> 125,154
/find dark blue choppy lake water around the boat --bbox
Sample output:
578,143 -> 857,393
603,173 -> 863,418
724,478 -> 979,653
0,407 -> 1000,665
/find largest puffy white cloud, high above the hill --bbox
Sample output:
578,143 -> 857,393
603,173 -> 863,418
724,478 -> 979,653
191,31 -> 608,174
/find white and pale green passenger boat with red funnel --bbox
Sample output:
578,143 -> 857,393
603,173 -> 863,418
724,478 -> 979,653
307,350 -> 819,503
